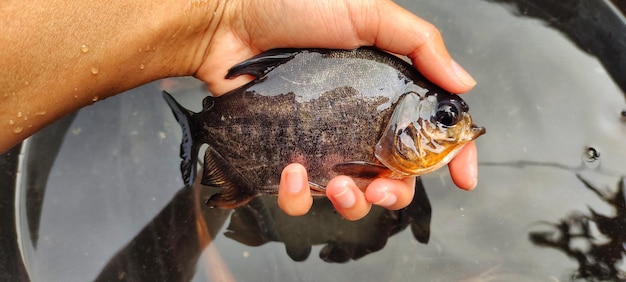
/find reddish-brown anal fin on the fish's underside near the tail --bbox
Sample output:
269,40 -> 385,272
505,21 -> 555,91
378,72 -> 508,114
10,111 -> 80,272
202,146 -> 260,208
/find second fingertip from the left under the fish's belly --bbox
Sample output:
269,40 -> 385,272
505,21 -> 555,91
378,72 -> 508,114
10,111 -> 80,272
326,176 -> 372,220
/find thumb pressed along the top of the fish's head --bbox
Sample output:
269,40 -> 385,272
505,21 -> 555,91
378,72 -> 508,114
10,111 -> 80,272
355,1 -> 476,93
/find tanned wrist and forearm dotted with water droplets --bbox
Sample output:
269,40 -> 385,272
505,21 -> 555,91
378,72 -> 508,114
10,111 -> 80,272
0,0 -> 224,153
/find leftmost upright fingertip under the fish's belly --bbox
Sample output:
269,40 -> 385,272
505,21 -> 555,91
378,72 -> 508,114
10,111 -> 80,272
278,164 -> 313,216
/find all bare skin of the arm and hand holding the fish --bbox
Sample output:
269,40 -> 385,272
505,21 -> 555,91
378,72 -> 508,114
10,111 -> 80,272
0,0 -> 477,220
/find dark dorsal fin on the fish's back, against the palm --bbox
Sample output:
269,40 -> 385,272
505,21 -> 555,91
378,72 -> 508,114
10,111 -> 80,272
226,49 -> 302,79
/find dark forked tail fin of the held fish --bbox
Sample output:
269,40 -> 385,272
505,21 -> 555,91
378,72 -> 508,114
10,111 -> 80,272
163,91 -> 201,187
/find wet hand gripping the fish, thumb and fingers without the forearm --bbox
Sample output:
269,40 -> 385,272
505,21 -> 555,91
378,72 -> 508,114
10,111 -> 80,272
196,0 -> 477,220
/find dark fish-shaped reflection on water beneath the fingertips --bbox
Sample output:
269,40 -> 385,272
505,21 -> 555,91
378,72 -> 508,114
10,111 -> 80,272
225,179 -> 431,262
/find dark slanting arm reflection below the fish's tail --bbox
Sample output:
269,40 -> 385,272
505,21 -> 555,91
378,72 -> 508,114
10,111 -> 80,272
95,183 -> 231,281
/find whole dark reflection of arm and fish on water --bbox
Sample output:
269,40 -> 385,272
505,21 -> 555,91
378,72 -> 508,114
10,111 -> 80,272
95,179 -> 431,281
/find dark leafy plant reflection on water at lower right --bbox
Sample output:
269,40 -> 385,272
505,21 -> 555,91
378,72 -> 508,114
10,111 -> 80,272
529,175 -> 626,281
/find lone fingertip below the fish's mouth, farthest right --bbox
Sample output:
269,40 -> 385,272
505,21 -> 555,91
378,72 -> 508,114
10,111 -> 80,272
448,141 -> 478,190
